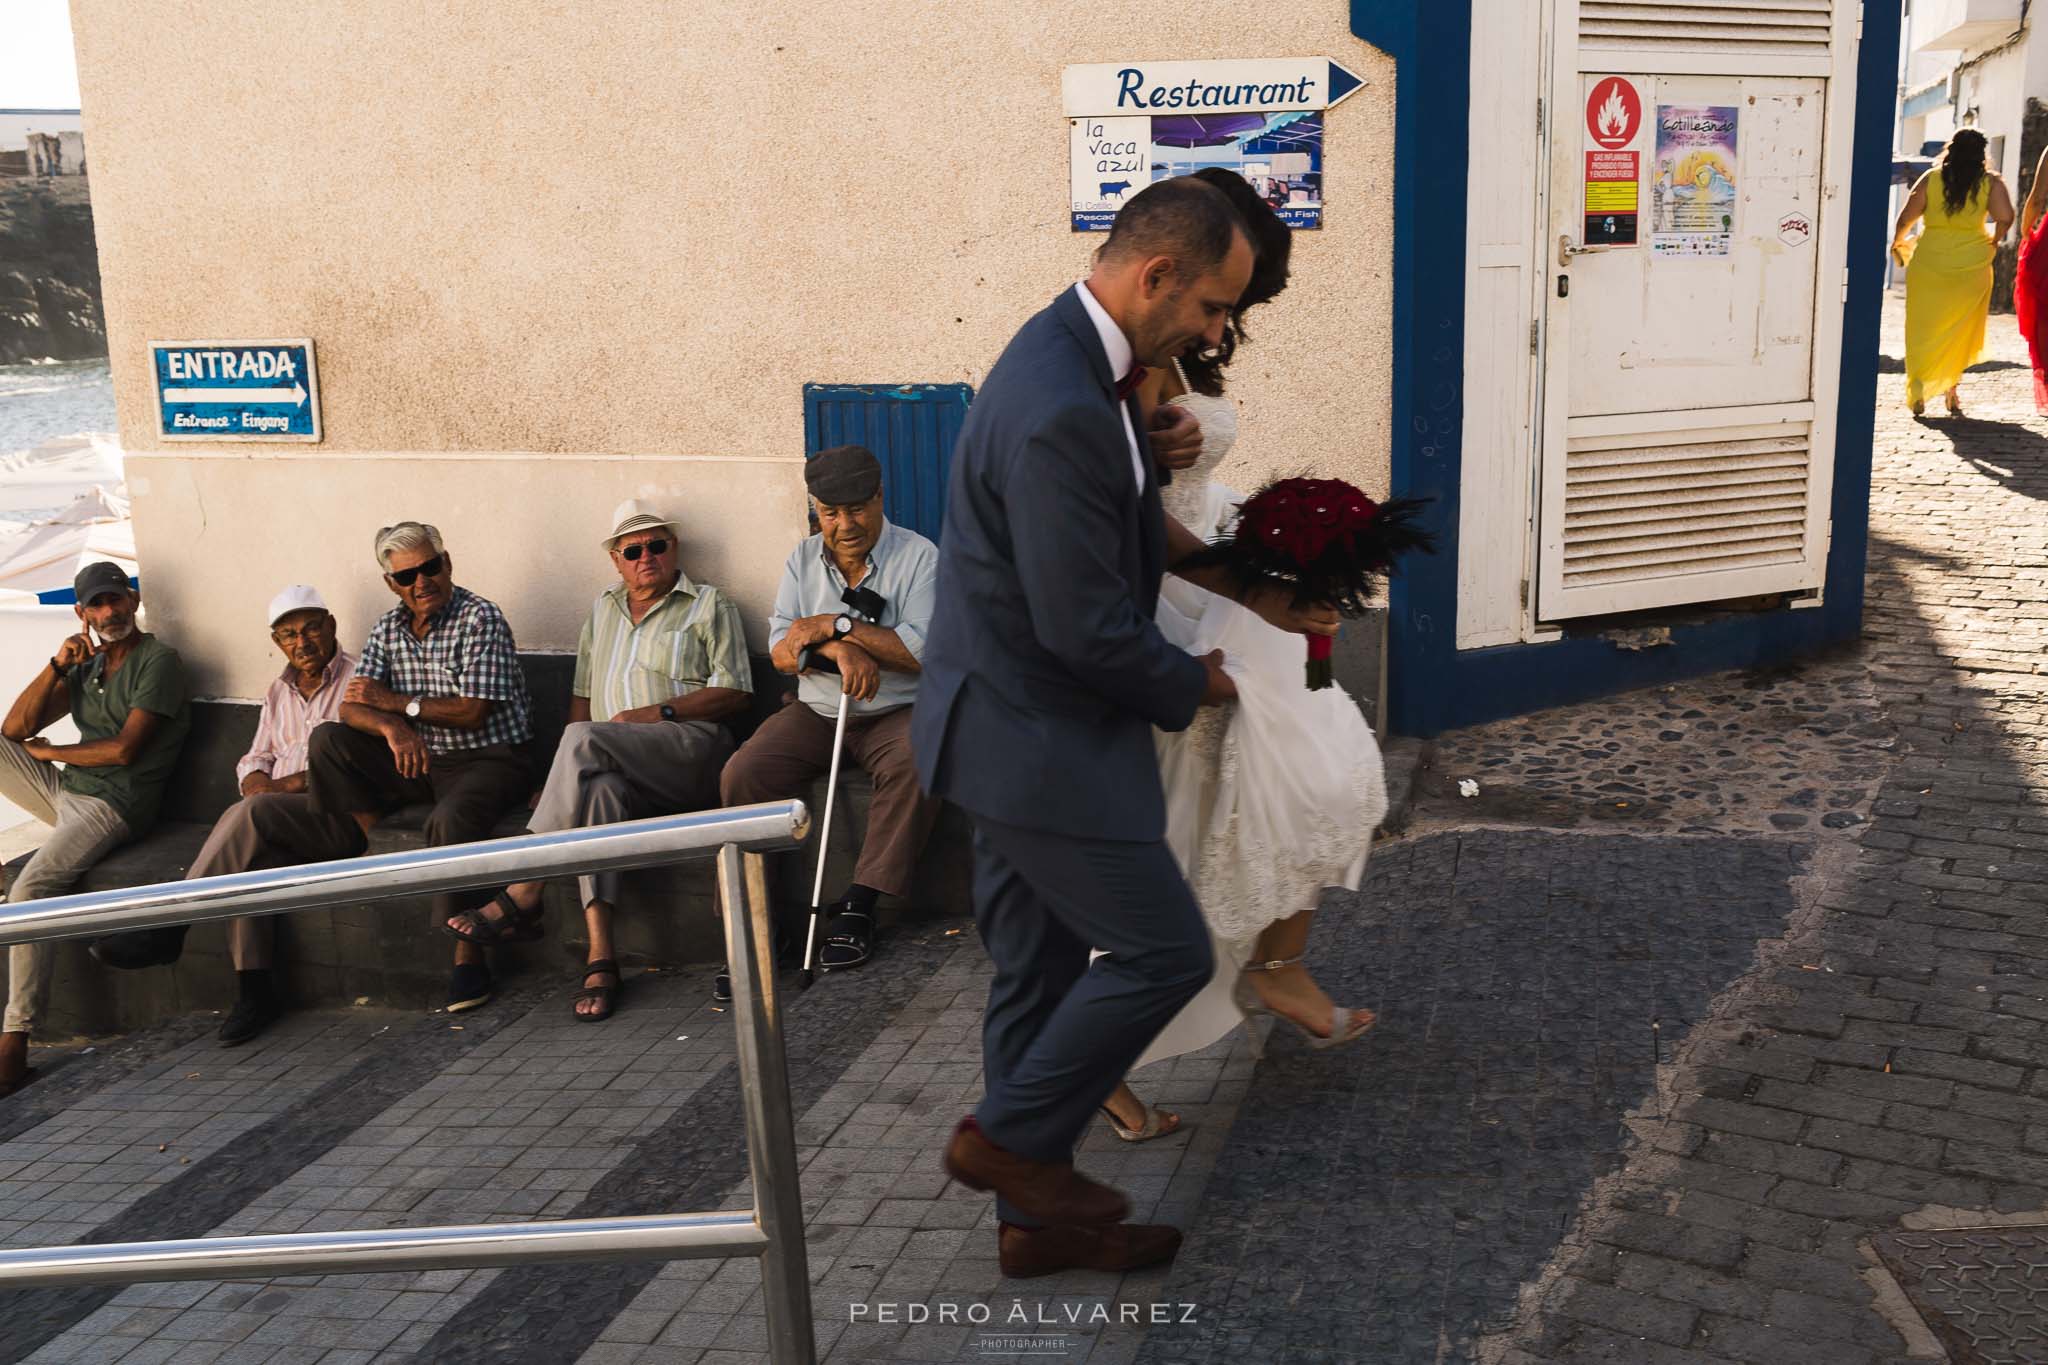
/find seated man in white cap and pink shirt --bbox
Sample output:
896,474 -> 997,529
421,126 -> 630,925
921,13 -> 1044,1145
92,583 -> 362,1048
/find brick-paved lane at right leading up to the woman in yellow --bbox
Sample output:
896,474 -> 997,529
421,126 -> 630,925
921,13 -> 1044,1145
1487,311 -> 2048,1365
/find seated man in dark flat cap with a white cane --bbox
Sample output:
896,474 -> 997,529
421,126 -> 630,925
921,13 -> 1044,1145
721,446 -> 938,986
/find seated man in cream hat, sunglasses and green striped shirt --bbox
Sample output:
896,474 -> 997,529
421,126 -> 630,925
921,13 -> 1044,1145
449,497 -> 754,1023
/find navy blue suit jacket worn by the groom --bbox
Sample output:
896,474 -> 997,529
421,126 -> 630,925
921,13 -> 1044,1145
911,289 -> 1208,841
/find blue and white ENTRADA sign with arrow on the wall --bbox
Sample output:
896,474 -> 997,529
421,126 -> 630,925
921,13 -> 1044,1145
150,338 -> 319,442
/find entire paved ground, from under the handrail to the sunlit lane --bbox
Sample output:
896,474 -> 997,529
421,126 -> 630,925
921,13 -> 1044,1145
12,298 -> 2048,1365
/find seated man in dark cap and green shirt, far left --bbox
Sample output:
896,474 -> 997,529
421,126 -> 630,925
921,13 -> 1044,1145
0,561 -> 193,1095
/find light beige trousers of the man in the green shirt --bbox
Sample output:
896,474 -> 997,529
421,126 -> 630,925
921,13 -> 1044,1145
0,739 -> 129,1033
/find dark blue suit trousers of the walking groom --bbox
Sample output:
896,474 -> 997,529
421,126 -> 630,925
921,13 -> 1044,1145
975,817 -> 1214,1226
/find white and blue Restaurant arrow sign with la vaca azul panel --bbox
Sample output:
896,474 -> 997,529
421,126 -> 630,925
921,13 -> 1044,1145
1061,57 -> 1364,231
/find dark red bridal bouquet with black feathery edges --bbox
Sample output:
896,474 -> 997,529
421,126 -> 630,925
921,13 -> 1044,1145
1184,479 -> 1436,690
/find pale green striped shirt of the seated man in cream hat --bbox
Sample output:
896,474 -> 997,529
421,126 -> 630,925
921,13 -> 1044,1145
569,573 -> 754,720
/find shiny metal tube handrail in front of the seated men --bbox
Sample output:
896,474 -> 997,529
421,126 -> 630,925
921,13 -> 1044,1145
0,800 -> 817,1365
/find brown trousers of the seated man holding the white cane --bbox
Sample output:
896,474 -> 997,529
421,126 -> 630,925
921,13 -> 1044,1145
719,702 -> 938,896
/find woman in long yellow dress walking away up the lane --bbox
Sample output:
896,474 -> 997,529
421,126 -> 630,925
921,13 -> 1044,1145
1892,129 -> 2013,417
